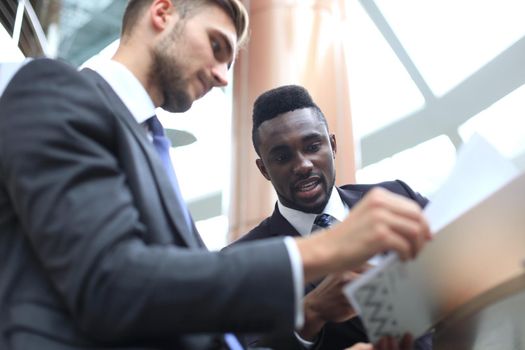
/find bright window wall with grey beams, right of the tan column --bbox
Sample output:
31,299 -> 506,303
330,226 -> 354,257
346,0 -> 525,194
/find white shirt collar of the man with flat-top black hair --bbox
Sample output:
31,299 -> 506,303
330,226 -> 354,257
277,187 -> 350,236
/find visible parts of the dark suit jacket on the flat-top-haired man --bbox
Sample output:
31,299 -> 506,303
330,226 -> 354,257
234,180 -> 431,350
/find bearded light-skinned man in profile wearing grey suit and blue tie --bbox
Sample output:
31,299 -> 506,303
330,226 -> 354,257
0,0 -> 429,350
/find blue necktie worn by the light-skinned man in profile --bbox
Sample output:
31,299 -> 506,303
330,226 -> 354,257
146,116 -> 192,232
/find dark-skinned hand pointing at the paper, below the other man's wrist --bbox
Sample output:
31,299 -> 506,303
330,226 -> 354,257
298,264 -> 370,341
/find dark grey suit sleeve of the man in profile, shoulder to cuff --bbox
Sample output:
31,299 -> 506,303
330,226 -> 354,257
0,60 -> 294,341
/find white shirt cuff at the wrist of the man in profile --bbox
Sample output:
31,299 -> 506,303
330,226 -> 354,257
284,237 -> 304,329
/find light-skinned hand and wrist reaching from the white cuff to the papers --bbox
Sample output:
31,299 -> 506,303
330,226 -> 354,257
296,187 -> 431,281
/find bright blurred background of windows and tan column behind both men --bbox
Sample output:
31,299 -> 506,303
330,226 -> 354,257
0,0 -> 525,249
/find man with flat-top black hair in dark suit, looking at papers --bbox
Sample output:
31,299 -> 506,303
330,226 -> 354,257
235,85 -> 431,349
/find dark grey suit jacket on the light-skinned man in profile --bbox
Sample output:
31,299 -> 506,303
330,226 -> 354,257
0,59 -> 294,350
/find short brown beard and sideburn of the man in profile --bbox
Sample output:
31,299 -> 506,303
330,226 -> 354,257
149,21 -> 193,113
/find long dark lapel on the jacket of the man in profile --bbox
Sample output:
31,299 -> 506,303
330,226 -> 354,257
82,69 -> 204,247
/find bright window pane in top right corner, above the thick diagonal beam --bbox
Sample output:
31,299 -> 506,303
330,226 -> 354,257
376,0 -> 525,96
